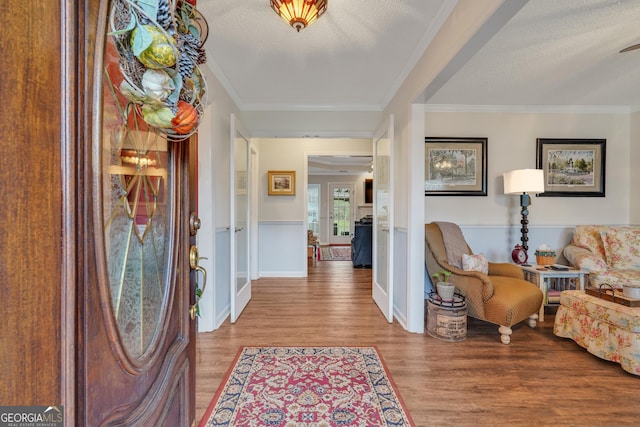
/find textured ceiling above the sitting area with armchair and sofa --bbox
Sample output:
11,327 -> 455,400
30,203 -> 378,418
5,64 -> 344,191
429,0 -> 640,107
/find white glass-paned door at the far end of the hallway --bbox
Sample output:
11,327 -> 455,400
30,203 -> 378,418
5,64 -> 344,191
329,183 -> 354,245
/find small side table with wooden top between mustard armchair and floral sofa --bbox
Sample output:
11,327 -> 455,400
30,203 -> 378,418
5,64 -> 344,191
520,265 -> 589,322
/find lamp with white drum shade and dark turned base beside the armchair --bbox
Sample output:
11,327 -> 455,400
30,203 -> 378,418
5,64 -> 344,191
503,169 -> 544,264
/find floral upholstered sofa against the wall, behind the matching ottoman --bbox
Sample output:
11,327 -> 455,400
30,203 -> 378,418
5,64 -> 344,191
563,225 -> 640,288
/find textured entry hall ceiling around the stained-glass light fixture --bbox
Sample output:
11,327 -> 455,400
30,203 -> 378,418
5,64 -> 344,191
198,0 -> 454,110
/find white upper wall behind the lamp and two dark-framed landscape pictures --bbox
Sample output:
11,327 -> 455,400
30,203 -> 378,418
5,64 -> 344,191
425,112 -> 631,226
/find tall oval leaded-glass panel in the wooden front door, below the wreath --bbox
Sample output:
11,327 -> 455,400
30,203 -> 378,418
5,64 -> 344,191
100,35 -> 175,359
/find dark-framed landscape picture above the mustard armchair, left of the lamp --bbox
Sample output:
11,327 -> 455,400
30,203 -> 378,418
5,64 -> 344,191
424,137 -> 487,196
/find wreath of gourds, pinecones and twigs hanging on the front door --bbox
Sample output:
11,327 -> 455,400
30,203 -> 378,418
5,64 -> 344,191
109,0 -> 208,141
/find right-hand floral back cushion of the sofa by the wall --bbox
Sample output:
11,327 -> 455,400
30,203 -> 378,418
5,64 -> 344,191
601,227 -> 640,269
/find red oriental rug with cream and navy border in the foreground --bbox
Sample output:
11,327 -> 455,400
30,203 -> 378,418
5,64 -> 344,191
198,347 -> 414,427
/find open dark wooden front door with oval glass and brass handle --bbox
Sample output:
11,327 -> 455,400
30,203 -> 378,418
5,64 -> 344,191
77,0 -> 198,426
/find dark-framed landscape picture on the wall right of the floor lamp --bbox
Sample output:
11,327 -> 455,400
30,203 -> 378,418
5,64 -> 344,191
536,138 -> 607,197
